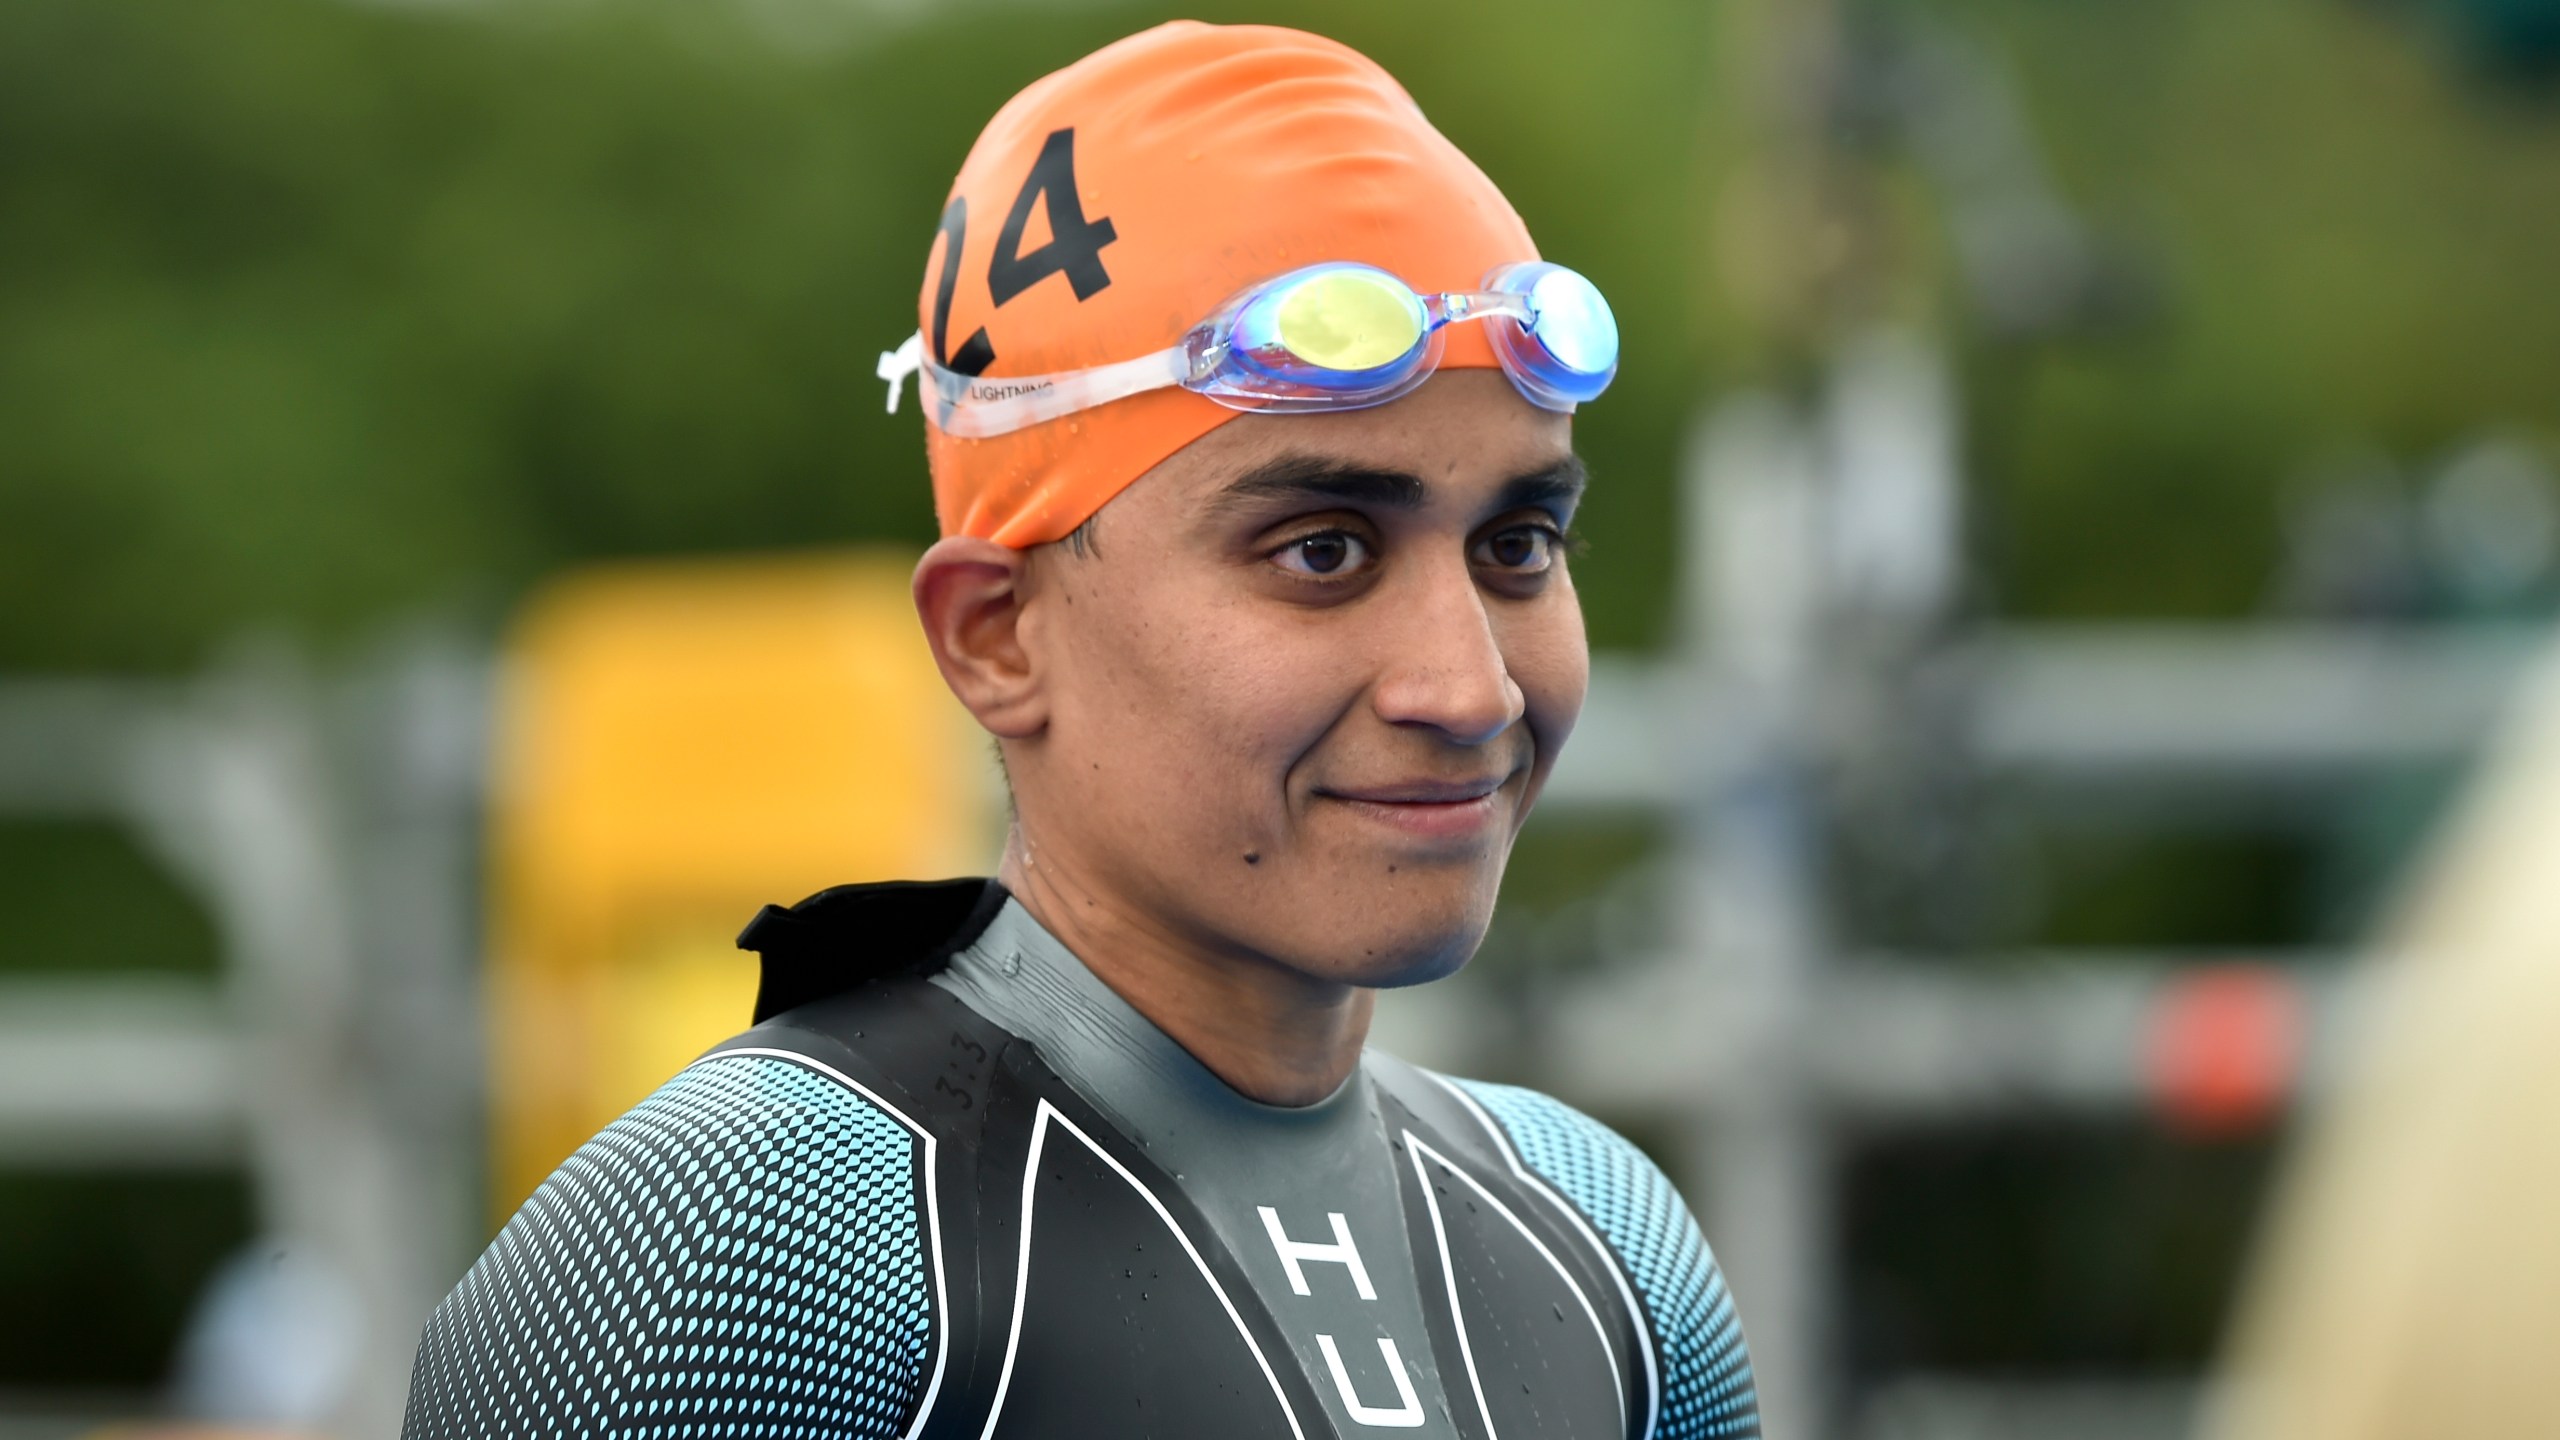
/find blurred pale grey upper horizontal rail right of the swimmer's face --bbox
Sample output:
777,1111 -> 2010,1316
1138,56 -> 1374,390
1539,620 -> 2550,822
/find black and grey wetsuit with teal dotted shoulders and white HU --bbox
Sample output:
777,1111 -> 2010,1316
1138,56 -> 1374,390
404,881 -> 1759,1440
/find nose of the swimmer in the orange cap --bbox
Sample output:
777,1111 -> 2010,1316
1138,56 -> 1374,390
1372,564 -> 1528,746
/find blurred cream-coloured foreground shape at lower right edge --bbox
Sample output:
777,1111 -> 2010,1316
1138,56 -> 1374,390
2207,635 -> 2560,1440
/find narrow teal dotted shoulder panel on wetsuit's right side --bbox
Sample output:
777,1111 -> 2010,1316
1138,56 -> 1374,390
1457,1081 -> 1759,1440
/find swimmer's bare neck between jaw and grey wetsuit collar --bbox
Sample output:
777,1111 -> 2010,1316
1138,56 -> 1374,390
998,828 -> 1377,1104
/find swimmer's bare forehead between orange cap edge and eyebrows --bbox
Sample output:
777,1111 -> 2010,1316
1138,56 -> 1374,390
1108,369 -> 1572,523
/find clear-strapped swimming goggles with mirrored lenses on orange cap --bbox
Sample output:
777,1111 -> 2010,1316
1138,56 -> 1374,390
878,261 -> 1618,441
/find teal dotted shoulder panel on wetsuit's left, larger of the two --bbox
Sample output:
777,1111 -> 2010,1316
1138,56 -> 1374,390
402,1056 -> 932,1440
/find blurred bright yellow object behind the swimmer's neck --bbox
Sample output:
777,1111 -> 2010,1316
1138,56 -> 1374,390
486,553 -> 993,1220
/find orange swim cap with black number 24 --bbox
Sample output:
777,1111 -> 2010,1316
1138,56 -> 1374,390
916,20 -> 1539,548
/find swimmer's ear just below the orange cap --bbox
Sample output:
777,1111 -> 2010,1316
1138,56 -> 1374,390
914,536 -> 1050,740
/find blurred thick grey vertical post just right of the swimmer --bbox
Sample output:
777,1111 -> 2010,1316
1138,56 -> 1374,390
1672,397 -> 1833,1437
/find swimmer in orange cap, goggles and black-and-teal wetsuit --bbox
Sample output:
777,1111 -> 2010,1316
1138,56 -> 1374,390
404,23 -> 1759,1440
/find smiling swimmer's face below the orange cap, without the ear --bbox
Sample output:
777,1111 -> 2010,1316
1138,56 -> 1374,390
963,369 -> 1590,986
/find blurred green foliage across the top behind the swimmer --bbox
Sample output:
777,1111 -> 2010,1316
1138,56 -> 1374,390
0,0 -> 2560,669
